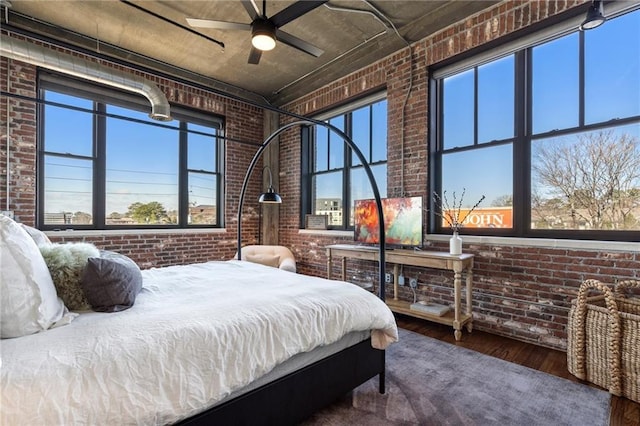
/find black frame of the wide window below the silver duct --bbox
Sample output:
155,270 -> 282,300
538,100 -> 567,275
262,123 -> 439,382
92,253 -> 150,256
36,70 -> 226,230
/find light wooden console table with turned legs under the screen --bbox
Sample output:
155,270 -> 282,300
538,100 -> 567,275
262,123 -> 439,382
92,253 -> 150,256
326,244 -> 473,340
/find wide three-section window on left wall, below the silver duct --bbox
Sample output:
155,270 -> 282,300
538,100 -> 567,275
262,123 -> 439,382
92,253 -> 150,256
38,73 -> 224,229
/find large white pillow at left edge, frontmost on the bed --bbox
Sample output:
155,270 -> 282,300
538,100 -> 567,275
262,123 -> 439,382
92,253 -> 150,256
0,215 -> 72,339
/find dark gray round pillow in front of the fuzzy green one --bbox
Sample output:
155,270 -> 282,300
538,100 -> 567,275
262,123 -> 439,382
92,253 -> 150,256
80,251 -> 142,312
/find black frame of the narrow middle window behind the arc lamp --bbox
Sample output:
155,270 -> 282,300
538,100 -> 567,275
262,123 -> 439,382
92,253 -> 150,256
300,91 -> 388,231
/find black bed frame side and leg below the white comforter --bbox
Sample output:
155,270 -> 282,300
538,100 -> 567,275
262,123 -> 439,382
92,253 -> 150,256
178,339 -> 385,426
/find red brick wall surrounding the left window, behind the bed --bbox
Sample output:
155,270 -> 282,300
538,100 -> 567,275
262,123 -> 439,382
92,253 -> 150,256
0,35 -> 263,268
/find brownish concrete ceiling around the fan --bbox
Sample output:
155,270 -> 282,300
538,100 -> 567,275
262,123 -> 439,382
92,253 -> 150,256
2,0 -> 498,106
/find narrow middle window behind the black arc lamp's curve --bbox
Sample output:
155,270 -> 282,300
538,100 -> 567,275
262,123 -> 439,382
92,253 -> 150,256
301,94 -> 387,229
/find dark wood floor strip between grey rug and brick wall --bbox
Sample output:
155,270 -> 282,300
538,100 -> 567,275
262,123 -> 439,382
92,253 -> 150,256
396,315 -> 640,426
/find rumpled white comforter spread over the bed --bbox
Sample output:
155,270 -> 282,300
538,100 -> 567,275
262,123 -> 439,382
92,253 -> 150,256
0,261 -> 397,426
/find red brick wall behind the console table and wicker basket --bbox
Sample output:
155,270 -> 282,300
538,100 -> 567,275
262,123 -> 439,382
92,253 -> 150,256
280,0 -> 640,349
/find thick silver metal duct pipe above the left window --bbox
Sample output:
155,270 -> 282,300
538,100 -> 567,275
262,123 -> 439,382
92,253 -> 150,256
0,34 -> 172,121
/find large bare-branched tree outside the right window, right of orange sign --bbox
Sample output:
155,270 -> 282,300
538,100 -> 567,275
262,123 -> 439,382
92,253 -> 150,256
532,130 -> 640,229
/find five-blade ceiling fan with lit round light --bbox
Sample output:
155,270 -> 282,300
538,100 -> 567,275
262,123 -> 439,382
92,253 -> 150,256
187,0 -> 327,64
